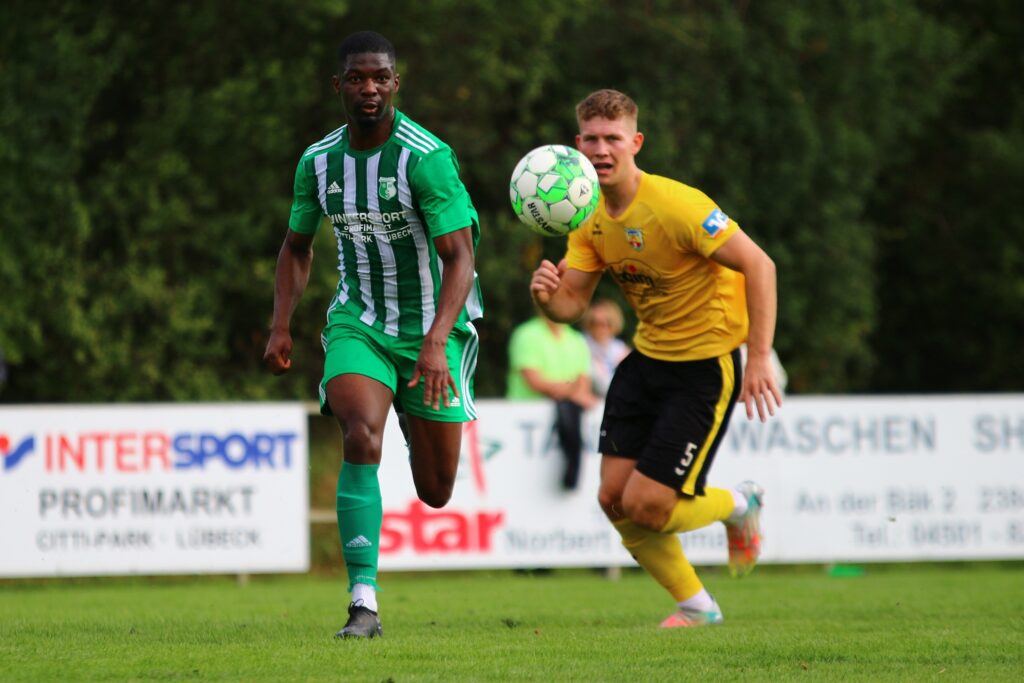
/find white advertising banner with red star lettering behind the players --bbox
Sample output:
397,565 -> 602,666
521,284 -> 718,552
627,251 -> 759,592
380,394 -> 1024,569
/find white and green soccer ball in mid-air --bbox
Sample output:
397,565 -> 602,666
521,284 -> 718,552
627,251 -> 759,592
509,144 -> 601,237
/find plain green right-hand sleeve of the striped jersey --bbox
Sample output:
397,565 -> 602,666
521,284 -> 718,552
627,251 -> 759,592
410,147 -> 476,238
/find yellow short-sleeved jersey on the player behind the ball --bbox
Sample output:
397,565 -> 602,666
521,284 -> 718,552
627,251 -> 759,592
565,173 -> 749,360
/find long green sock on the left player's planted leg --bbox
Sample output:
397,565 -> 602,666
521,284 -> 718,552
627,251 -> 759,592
338,463 -> 384,591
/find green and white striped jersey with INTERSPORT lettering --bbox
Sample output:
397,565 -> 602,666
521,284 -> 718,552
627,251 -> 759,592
289,110 -> 483,337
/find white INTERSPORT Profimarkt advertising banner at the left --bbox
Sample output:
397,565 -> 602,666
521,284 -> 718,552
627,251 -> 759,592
0,403 -> 309,577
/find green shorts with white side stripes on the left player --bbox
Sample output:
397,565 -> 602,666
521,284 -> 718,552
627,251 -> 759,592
319,311 -> 479,422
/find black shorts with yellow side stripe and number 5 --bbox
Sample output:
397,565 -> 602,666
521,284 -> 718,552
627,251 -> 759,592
598,350 -> 742,496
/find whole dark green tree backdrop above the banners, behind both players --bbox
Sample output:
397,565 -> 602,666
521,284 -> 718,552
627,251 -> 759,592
0,0 -> 1024,401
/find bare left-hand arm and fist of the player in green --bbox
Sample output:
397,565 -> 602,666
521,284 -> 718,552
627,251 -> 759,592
263,229 -> 313,375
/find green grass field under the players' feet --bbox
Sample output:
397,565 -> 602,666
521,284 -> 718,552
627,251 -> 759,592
0,564 -> 1024,683
